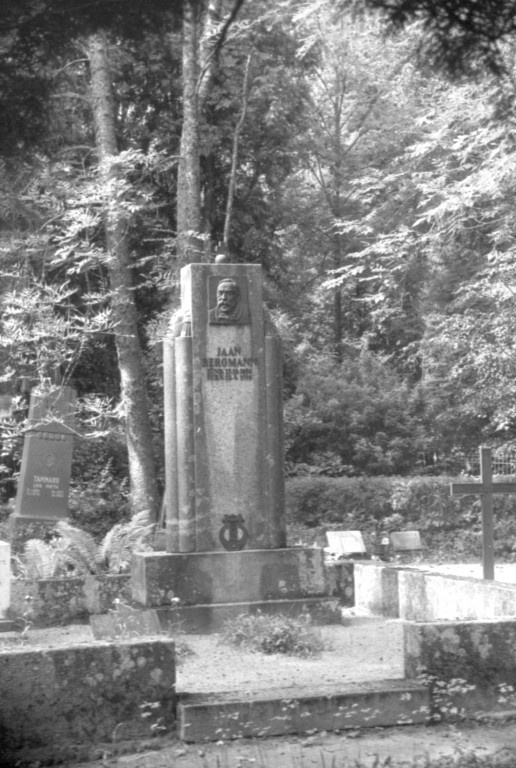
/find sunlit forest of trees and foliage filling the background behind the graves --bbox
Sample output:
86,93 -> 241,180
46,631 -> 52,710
0,0 -> 516,560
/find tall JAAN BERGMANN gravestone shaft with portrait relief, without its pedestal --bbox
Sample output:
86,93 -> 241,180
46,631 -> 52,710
164,264 -> 285,552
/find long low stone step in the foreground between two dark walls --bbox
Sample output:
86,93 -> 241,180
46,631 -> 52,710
177,680 -> 430,743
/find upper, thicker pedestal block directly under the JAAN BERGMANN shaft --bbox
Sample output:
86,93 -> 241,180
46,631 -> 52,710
131,547 -> 327,607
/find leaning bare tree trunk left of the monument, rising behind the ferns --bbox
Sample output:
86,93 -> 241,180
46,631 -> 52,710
88,33 -> 160,518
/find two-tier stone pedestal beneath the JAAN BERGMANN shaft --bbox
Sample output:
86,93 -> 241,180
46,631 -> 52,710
131,547 -> 341,632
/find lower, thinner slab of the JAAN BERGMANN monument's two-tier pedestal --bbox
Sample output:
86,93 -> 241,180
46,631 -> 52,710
157,597 -> 342,634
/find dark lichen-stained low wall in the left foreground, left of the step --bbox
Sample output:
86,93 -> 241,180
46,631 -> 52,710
0,639 -> 175,765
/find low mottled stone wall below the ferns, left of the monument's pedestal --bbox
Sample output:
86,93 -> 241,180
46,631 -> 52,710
8,574 -> 131,627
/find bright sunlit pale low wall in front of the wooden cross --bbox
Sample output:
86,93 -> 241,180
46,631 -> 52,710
355,563 -> 516,622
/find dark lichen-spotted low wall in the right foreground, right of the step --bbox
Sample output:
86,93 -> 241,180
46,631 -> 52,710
404,619 -> 516,714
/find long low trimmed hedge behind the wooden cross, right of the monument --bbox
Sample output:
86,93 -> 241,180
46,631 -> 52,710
287,476 -> 516,558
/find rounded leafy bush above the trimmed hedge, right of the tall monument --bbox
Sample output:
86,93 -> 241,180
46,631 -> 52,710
284,350 -> 432,477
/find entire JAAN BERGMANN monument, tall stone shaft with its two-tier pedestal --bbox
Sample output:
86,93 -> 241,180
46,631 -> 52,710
132,263 -> 335,629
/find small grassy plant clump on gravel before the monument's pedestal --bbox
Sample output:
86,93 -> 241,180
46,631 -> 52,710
222,613 -> 325,658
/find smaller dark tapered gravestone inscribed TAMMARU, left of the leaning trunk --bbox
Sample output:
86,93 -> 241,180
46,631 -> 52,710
9,387 -> 75,550
